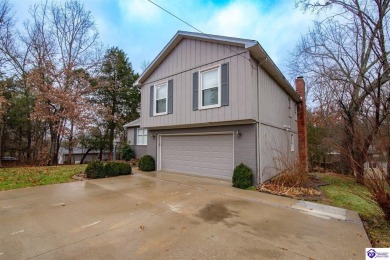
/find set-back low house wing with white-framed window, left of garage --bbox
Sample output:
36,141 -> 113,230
123,119 -> 148,158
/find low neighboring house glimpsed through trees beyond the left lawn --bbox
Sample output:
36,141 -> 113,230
58,147 -> 109,164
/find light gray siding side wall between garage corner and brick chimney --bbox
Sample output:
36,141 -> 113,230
258,68 -> 298,182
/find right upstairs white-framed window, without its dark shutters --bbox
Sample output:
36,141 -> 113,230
200,67 -> 221,108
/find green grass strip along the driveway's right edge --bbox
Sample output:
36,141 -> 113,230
318,174 -> 390,247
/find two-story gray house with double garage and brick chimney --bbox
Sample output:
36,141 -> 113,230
133,31 -> 307,183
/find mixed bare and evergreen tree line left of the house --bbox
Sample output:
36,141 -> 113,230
0,0 -> 140,165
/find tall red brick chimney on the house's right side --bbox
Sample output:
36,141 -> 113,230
295,77 -> 309,171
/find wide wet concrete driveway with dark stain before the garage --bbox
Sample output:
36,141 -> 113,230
0,173 -> 370,259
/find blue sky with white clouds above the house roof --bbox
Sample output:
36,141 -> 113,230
10,0 -> 315,77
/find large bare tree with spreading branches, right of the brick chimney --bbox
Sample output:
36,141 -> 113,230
290,0 -> 390,183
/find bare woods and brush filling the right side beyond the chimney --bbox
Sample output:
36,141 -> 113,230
290,0 -> 390,223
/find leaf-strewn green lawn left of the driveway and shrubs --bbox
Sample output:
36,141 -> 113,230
0,164 -> 87,190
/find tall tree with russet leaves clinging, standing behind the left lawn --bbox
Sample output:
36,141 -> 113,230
27,1 -> 98,165
